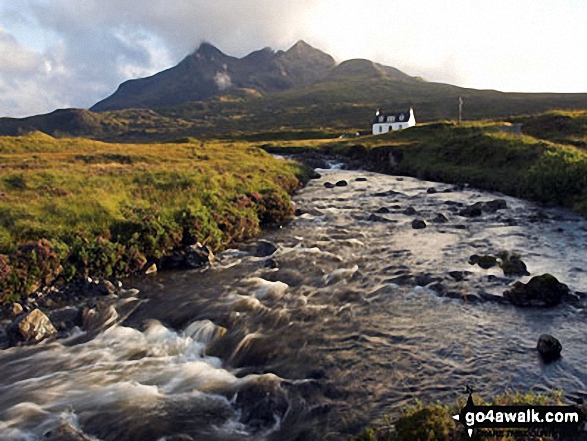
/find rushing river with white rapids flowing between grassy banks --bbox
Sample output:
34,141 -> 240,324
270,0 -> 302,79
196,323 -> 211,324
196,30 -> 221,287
0,170 -> 587,440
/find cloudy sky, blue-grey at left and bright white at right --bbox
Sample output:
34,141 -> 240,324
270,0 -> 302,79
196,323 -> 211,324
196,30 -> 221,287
0,0 -> 587,116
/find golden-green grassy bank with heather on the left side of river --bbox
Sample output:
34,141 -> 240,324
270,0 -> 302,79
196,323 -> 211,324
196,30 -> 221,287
0,132 -> 309,303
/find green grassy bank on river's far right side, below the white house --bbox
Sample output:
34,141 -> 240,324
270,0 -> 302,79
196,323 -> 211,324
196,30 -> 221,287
264,112 -> 587,215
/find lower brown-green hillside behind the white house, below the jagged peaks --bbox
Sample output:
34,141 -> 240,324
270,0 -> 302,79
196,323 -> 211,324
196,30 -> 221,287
0,78 -> 587,142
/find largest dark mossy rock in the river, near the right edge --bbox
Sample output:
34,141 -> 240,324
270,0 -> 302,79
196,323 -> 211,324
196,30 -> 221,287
503,274 -> 569,307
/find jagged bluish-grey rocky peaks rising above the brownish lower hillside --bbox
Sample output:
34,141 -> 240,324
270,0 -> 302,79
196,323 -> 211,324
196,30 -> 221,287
90,41 -> 342,112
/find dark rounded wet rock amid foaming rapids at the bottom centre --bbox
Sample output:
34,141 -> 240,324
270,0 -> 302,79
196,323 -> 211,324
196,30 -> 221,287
234,375 -> 289,431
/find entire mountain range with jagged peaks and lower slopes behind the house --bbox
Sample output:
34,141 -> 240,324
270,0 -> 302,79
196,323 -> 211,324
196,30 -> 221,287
0,41 -> 587,141
